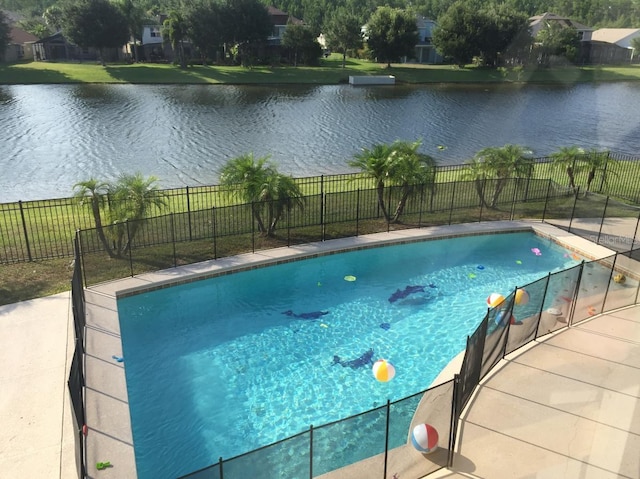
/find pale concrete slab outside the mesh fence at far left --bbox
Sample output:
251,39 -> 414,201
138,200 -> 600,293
0,293 -> 77,479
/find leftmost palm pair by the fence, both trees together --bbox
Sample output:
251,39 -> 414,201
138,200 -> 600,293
74,173 -> 166,258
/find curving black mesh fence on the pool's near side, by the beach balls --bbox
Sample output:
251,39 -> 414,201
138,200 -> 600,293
170,246 -> 640,479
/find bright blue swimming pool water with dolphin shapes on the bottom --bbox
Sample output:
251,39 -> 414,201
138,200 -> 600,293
118,233 -> 577,479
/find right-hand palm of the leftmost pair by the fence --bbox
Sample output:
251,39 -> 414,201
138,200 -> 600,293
108,173 -> 166,255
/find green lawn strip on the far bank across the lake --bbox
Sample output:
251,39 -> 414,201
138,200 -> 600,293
0,60 -> 640,85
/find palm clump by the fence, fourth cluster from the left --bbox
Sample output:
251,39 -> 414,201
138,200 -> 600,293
467,145 -> 533,208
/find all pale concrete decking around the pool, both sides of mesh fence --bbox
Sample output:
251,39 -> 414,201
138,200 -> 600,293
0,222 -> 640,479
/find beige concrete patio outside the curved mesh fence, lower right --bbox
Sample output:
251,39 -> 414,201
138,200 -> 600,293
429,306 -> 640,479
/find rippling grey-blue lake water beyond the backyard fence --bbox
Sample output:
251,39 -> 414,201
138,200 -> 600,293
0,83 -> 640,202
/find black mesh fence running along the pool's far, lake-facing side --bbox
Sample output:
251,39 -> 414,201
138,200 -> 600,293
78,179 -> 640,284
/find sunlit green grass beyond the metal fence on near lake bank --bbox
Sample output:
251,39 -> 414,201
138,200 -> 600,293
0,153 -> 640,264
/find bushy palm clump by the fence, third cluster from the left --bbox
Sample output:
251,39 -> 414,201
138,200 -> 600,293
348,141 -> 436,223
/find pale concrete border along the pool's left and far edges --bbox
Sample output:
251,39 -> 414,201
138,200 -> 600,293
80,221 -> 614,479
